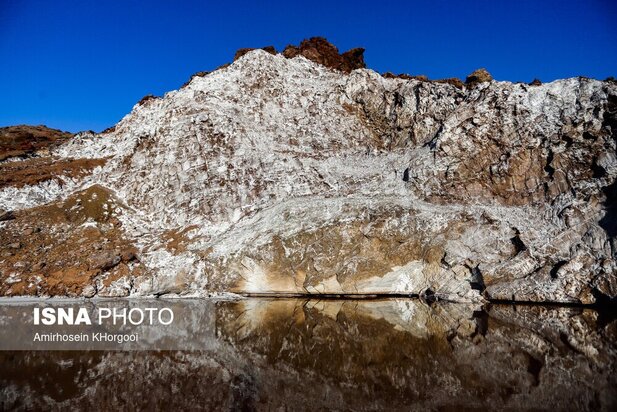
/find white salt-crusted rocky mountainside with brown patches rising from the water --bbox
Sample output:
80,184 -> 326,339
0,39 -> 617,303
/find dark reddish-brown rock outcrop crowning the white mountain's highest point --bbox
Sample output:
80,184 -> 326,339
282,37 -> 366,73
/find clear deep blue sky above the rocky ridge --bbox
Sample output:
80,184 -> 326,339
0,0 -> 617,132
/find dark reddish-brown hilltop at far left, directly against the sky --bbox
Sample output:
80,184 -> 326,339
0,125 -> 73,161
